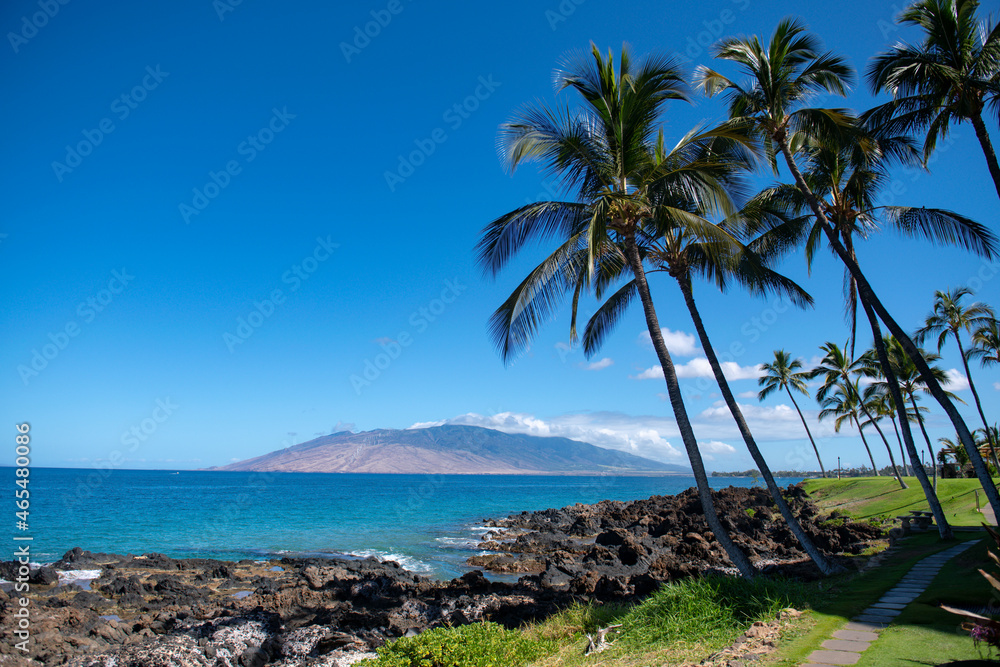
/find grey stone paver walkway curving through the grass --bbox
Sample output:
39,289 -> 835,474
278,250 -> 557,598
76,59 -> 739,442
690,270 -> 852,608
804,540 -> 978,666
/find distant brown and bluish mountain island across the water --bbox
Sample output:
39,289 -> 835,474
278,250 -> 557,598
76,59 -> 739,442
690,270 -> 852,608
209,425 -> 691,475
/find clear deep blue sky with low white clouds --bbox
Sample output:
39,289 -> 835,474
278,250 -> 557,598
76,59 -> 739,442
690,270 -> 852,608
0,0 -> 1000,470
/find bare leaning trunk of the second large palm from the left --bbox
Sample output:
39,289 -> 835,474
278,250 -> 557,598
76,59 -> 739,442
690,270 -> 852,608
677,277 -> 845,574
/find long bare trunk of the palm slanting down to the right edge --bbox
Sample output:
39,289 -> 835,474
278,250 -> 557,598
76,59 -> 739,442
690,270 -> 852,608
774,136 -> 1000,516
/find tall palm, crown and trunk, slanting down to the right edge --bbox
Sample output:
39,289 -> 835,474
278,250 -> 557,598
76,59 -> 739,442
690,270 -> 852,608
696,14 -> 1000,520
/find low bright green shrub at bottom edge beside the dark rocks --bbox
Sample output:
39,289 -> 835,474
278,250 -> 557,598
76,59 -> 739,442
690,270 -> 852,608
358,623 -> 556,667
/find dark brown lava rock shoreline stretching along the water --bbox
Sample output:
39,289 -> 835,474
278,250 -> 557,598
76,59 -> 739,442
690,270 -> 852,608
0,487 -> 881,667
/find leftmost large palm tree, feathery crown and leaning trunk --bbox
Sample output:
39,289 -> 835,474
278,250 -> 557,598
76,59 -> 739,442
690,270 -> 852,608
478,45 -> 755,577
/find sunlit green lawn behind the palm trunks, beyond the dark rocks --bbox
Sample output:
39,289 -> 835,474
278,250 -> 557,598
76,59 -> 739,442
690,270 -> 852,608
802,477 -> 986,526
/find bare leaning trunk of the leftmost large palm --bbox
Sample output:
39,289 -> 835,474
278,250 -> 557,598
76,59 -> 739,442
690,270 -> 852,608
625,234 -> 756,578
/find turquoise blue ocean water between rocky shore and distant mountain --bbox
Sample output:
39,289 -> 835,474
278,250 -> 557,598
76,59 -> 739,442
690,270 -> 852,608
11,468 -> 799,578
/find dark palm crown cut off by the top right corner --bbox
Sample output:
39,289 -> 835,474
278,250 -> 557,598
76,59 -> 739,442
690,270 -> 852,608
866,0 -> 1000,201
